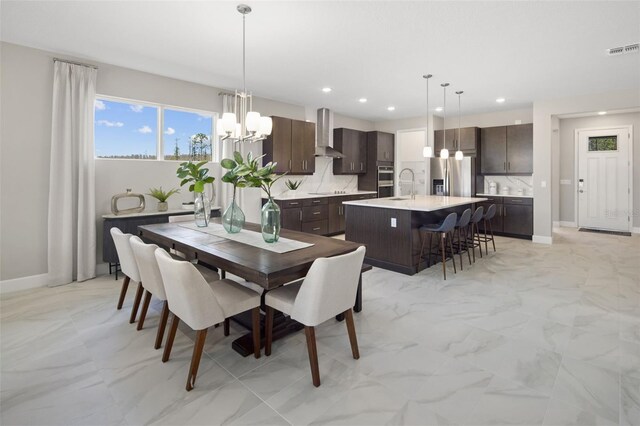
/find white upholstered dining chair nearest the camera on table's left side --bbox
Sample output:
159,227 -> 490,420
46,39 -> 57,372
155,249 -> 260,391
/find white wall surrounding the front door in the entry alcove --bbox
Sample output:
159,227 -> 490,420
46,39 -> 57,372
554,112 -> 640,228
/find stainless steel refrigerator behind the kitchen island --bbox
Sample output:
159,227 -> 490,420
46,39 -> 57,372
429,156 -> 476,197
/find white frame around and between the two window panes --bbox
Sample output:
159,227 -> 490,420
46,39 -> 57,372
93,94 -> 220,163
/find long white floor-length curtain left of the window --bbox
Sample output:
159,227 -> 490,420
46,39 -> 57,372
48,61 -> 97,285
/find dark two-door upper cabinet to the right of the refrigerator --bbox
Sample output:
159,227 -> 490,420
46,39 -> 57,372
480,124 -> 533,174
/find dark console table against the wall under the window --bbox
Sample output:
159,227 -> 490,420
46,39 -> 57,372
102,207 -> 220,280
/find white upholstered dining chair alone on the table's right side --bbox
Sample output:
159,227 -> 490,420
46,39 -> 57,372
265,246 -> 365,387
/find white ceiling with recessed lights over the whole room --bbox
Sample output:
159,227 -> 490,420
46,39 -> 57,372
0,0 -> 640,121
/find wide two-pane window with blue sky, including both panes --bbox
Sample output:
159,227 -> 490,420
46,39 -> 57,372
94,96 -> 215,161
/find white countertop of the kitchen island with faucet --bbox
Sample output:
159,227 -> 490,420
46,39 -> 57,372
343,195 -> 487,212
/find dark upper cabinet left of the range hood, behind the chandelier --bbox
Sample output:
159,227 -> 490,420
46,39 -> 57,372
262,117 -> 316,175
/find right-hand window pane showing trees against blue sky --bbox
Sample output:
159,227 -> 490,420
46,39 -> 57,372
162,108 -> 213,161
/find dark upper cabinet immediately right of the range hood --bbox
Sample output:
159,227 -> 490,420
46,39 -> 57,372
333,128 -> 367,175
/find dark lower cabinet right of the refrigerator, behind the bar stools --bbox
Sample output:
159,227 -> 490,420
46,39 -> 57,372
477,197 -> 533,238
